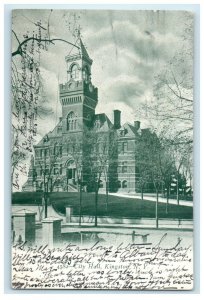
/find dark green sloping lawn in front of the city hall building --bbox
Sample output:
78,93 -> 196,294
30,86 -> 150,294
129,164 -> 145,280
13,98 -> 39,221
12,192 -> 193,219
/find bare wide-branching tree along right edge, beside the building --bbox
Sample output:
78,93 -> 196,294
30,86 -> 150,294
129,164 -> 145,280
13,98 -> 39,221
135,12 -> 193,206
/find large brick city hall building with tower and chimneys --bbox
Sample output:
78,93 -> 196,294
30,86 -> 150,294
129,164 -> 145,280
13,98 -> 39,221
23,39 -> 152,192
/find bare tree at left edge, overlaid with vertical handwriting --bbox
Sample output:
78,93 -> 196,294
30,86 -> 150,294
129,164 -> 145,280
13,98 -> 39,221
11,10 -> 79,191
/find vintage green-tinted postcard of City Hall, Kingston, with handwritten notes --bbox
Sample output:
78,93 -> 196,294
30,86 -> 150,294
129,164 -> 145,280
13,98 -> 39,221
11,9 -> 194,290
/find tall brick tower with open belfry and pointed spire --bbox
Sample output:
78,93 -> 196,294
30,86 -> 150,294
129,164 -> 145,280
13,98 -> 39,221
59,38 -> 98,134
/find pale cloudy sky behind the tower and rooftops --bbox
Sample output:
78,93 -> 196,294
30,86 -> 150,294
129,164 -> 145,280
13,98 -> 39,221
12,10 -> 192,140
